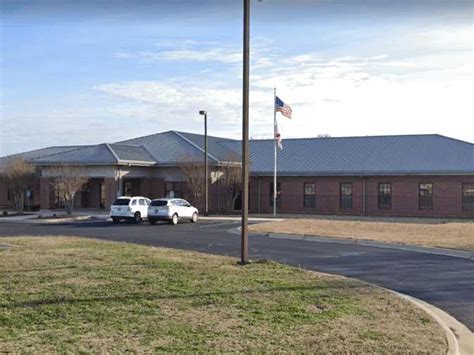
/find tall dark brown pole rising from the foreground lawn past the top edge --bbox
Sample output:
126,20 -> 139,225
240,0 -> 250,264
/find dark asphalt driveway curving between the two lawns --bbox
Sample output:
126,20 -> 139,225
0,221 -> 474,331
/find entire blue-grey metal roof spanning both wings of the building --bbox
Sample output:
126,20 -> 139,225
0,131 -> 474,176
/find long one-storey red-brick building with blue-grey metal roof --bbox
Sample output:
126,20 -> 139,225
0,131 -> 474,218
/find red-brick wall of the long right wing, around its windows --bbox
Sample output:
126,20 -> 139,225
250,176 -> 474,218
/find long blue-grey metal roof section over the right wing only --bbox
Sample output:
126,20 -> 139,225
222,134 -> 474,175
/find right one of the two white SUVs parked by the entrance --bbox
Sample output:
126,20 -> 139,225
148,198 -> 199,224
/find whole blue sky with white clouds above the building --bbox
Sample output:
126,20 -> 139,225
0,0 -> 474,156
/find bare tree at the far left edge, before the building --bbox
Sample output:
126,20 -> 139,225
0,157 -> 35,213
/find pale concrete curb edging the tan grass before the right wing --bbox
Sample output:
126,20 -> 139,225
264,233 -> 474,260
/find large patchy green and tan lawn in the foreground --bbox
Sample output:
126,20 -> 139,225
0,237 -> 446,354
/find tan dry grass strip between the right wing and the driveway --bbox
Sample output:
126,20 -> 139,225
250,219 -> 474,251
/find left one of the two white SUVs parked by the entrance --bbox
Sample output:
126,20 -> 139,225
110,196 -> 150,223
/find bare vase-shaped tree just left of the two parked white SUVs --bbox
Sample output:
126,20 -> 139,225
50,165 -> 88,215
